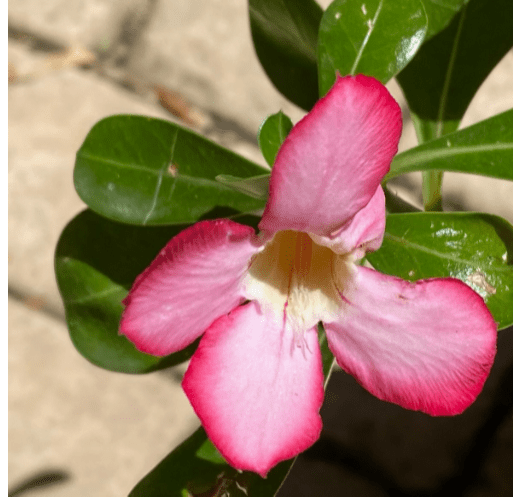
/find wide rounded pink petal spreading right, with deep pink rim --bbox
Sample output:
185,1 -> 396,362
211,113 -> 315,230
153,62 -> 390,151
325,267 -> 497,416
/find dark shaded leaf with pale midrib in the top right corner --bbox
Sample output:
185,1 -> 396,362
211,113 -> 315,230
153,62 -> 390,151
397,0 -> 513,143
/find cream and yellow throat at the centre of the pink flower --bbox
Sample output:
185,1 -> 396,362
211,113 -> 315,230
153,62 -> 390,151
245,231 -> 345,333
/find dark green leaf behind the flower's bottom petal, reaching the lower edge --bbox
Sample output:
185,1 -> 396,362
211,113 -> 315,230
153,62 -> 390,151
129,323 -> 334,497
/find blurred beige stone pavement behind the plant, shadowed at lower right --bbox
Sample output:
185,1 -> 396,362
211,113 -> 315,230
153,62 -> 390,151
8,0 -> 512,497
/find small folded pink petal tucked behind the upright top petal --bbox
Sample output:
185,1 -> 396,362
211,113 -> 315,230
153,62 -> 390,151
310,185 -> 386,261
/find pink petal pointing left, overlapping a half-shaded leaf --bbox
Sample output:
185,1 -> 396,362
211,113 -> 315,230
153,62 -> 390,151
120,219 -> 259,356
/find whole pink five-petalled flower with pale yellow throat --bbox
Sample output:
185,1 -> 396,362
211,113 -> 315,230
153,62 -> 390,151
121,75 -> 497,476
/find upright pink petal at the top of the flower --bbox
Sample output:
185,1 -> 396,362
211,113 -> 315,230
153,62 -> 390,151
259,75 -> 402,235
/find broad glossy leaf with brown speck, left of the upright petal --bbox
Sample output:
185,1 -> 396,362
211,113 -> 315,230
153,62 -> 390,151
74,115 -> 266,225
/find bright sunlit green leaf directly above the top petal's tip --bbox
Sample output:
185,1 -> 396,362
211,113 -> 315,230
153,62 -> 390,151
318,0 -> 428,96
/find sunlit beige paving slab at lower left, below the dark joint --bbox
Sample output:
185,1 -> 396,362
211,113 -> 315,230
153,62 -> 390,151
9,299 -> 198,497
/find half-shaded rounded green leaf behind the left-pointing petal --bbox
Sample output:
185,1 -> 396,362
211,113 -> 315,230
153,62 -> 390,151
55,209 -> 202,373
